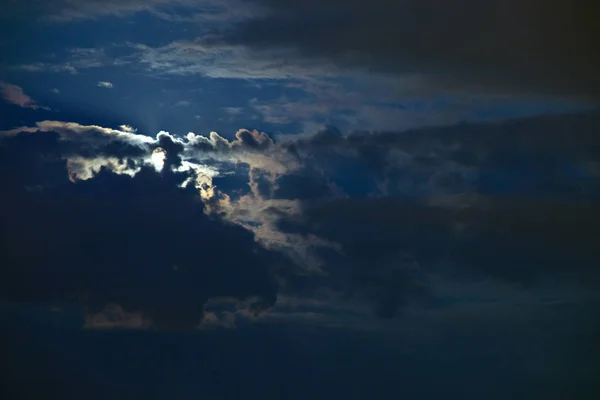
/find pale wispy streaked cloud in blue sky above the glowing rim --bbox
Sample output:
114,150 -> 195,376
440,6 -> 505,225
16,37 -> 452,128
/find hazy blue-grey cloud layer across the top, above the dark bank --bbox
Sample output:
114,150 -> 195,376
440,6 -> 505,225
5,0 -> 600,133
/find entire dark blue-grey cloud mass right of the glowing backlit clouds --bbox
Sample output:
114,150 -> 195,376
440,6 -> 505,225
258,113 -> 600,317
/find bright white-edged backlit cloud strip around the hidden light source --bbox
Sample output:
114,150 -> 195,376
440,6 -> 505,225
0,121 -> 295,188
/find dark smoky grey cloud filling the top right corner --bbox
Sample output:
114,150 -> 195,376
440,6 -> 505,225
224,0 -> 600,99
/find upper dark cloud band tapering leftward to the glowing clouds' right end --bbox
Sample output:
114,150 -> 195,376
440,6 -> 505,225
283,112 -> 600,198
